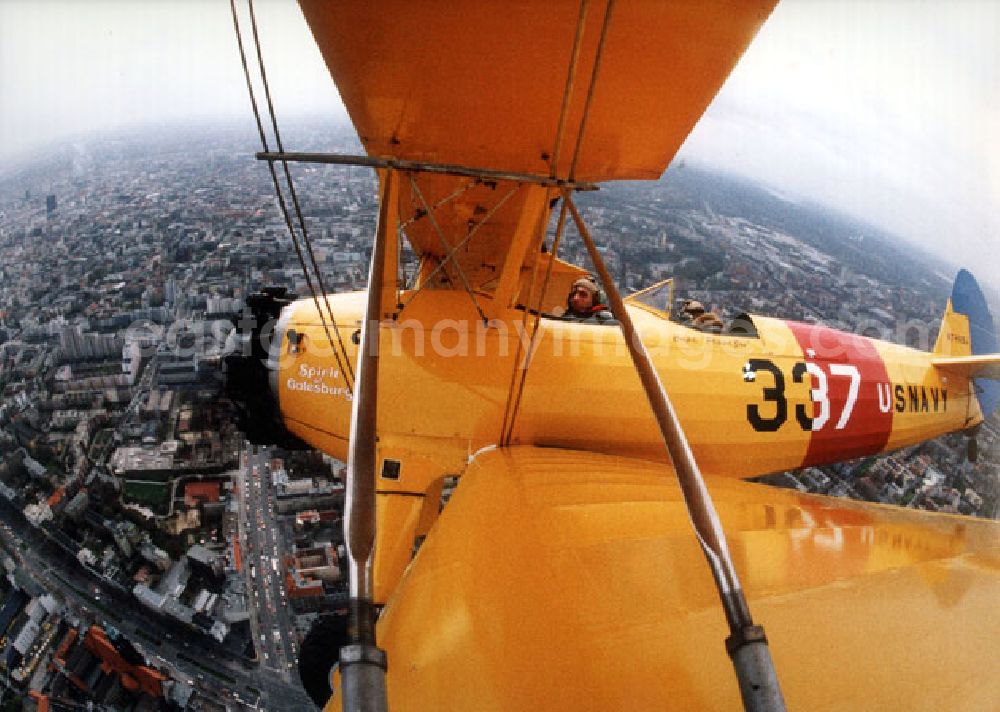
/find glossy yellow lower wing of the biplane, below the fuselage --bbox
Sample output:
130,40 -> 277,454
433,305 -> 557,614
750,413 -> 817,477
326,448 -> 1000,712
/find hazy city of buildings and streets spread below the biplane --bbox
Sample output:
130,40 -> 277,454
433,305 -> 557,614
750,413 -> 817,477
0,122 -> 1000,710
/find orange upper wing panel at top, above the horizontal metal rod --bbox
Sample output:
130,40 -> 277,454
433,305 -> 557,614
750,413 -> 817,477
300,0 -> 776,181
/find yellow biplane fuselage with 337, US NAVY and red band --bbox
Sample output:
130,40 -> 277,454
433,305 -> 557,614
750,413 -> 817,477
275,290 -> 980,601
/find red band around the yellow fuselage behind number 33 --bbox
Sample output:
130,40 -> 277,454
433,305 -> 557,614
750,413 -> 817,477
786,321 -> 892,467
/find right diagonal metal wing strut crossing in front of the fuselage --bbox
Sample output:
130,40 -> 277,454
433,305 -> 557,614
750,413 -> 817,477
563,190 -> 785,712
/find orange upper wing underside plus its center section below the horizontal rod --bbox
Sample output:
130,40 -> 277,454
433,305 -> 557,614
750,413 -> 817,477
292,0 -> 775,318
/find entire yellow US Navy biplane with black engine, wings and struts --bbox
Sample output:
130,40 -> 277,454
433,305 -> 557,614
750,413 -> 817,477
230,0 -> 1000,712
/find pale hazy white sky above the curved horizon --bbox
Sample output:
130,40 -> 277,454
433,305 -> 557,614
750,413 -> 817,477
0,0 -> 1000,285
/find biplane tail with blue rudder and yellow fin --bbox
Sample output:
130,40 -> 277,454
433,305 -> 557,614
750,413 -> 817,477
933,269 -> 1000,418
